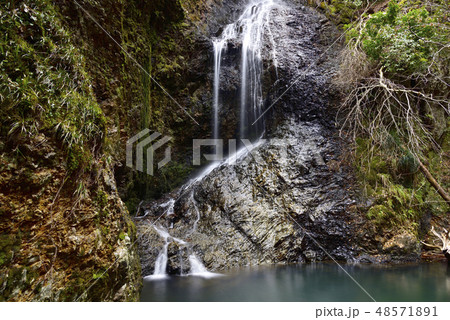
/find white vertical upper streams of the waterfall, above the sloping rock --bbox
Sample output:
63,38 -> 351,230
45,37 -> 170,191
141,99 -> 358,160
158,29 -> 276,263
213,0 -> 276,139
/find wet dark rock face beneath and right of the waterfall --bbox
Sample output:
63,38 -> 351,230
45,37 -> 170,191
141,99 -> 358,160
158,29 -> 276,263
138,1 -> 419,275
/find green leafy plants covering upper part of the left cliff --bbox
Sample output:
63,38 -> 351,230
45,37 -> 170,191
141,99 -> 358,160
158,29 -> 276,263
0,0 -> 106,171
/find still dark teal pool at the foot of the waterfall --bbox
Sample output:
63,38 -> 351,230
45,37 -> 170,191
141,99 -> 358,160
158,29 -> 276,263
141,263 -> 450,302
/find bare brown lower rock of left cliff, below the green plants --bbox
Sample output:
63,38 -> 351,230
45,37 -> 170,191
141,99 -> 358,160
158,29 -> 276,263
0,129 -> 140,301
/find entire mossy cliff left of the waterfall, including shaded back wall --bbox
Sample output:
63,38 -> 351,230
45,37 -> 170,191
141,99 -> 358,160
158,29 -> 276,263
0,0 -> 218,301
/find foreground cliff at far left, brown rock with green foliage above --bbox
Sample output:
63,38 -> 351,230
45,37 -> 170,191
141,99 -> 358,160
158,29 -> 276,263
0,0 -> 147,301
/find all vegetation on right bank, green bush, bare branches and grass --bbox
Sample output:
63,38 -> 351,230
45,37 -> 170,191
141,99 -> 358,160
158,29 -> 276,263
341,0 -> 450,231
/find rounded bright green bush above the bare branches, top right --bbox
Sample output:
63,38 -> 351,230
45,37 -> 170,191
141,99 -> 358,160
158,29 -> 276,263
347,1 -> 448,74
